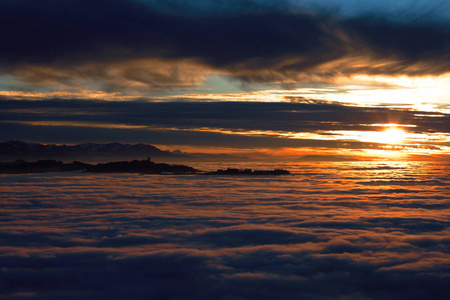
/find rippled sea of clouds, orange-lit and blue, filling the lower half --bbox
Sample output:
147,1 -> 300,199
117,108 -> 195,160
0,162 -> 450,300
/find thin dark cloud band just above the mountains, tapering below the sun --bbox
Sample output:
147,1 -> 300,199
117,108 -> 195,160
0,122 -> 370,149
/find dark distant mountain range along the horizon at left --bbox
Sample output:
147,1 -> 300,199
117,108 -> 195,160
0,141 -> 245,162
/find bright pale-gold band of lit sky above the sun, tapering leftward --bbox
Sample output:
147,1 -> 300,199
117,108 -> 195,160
173,73 -> 450,114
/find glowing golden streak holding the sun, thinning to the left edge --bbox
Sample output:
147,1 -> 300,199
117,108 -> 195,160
6,121 -> 450,156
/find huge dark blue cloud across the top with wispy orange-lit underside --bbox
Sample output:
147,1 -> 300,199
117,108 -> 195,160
0,0 -> 450,90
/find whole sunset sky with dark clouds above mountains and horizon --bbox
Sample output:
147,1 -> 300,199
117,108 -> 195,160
0,0 -> 450,159
